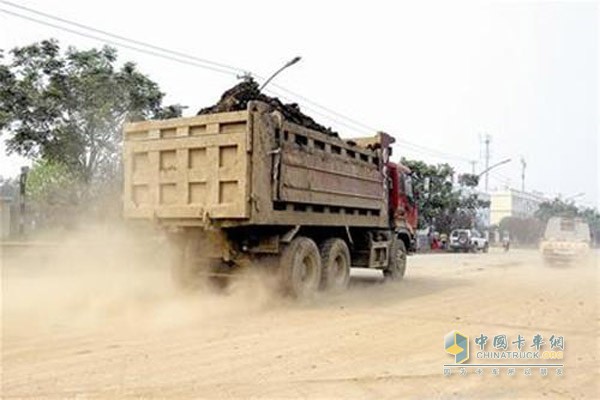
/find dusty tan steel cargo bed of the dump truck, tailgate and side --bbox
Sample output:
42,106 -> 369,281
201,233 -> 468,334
124,103 -> 387,227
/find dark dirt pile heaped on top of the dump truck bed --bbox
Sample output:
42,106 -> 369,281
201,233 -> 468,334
198,79 -> 338,137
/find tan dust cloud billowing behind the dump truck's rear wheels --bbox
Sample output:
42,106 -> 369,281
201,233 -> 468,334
1,225 -> 281,337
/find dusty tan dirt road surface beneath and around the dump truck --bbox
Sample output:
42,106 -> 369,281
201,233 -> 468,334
1,230 -> 600,399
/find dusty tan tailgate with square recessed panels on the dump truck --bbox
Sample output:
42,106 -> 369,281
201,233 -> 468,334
124,112 -> 249,219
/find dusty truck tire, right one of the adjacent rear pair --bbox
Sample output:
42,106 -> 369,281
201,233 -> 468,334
319,238 -> 350,291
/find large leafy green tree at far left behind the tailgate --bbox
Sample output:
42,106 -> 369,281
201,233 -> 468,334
0,40 -> 181,187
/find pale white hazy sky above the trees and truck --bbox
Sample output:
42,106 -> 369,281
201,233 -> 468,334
0,0 -> 600,205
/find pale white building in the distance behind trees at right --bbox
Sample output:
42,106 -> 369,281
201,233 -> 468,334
490,189 -> 546,225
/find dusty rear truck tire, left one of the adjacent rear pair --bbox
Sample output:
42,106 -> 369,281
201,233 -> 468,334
279,236 -> 322,298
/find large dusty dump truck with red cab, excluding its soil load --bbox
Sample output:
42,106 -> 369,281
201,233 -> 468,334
123,101 -> 417,296
